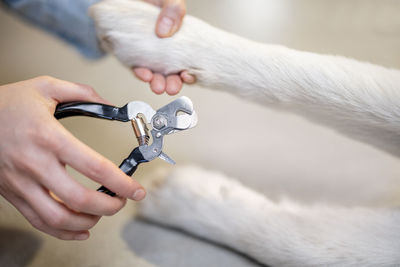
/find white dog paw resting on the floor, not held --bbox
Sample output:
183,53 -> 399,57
139,166 -> 246,228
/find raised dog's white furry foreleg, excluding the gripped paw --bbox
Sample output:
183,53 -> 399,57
190,32 -> 400,155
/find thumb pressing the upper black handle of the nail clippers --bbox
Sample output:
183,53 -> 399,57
35,76 -> 107,103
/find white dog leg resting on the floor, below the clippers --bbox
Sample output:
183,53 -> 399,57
139,167 -> 400,266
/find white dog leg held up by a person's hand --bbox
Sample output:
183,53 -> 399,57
91,0 -> 400,155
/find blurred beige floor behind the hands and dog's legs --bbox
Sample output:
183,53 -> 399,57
0,0 -> 400,267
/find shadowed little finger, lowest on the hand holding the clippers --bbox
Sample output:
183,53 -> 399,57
4,195 -> 90,240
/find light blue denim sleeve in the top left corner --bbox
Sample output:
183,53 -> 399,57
0,0 -> 104,58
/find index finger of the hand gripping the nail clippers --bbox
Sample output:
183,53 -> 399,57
50,124 -> 146,200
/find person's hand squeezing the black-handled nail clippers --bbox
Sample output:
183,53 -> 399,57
0,76 -> 145,240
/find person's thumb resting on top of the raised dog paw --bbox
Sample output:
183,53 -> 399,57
156,0 -> 186,38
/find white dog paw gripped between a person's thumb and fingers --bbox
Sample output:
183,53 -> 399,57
90,0 -> 214,77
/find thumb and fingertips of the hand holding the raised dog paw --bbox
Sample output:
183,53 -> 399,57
133,0 -> 196,95
